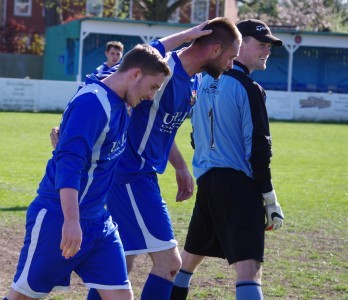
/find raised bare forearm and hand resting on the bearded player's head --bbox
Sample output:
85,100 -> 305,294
159,21 -> 212,52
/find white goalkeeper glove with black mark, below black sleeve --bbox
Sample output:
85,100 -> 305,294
262,190 -> 284,230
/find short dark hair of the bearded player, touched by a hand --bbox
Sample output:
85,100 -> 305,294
193,17 -> 241,48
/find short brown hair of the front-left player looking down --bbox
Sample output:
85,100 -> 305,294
117,44 -> 170,76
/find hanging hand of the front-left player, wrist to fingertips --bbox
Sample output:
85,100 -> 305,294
60,221 -> 82,259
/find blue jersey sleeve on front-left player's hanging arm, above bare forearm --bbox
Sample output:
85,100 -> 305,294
55,93 -> 107,190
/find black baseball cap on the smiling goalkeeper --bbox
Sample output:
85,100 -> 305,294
237,19 -> 283,47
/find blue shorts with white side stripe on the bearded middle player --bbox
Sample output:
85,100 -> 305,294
107,173 -> 177,255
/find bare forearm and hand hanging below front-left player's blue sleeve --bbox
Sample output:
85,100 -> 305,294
60,188 -> 82,259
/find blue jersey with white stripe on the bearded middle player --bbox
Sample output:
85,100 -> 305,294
115,41 -> 199,183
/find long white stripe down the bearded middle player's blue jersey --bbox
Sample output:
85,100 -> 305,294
138,54 -> 176,170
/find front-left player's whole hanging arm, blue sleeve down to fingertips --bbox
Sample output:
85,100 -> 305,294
54,94 -> 107,259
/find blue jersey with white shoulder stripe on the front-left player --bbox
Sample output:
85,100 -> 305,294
35,77 -> 131,218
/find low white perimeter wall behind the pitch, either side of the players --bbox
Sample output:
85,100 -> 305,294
0,78 -> 348,122
